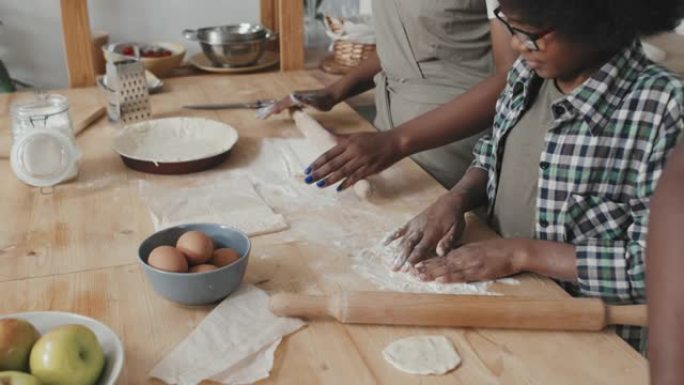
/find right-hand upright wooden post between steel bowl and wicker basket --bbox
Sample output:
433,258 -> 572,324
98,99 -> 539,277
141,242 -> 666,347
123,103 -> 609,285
278,0 -> 304,71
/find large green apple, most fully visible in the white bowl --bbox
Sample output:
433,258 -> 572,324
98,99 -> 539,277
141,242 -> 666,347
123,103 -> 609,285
31,325 -> 105,385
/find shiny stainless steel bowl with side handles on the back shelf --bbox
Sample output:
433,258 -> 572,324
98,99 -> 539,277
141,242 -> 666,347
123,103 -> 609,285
183,23 -> 275,67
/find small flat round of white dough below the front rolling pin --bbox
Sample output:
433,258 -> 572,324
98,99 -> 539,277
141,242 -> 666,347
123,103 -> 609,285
382,336 -> 461,375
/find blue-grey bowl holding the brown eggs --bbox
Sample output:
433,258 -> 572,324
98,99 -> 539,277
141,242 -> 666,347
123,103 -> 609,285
138,223 -> 252,305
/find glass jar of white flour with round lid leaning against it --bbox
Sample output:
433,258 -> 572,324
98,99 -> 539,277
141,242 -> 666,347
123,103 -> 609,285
10,94 -> 80,187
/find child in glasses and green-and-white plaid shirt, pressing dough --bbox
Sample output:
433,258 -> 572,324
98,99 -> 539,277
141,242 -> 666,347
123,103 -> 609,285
394,0 -> 684,351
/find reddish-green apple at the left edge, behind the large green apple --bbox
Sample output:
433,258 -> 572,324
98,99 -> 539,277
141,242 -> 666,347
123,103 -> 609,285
0,318 -> 40,372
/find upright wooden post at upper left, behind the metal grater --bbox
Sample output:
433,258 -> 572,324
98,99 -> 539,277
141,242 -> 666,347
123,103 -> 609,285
61,0 -> 95,87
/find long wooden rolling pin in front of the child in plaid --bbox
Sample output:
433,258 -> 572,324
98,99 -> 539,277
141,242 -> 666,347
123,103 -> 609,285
271,292 -> 646,331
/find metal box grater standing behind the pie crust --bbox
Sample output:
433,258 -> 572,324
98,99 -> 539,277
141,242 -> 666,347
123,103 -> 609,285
107,60 -> 151,124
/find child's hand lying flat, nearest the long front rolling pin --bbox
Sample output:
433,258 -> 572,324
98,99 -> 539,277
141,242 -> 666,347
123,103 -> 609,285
415,239 -> 532,283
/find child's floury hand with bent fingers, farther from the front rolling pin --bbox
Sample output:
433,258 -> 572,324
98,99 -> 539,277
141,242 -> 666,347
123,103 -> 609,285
385,193 -> 466,271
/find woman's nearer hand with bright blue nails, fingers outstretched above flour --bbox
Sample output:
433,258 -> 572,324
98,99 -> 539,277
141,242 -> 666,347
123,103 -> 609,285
305,132 -> 404,191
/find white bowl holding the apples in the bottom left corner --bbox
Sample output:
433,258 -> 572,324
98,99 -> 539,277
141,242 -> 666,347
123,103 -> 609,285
0,311 -> 124,385
